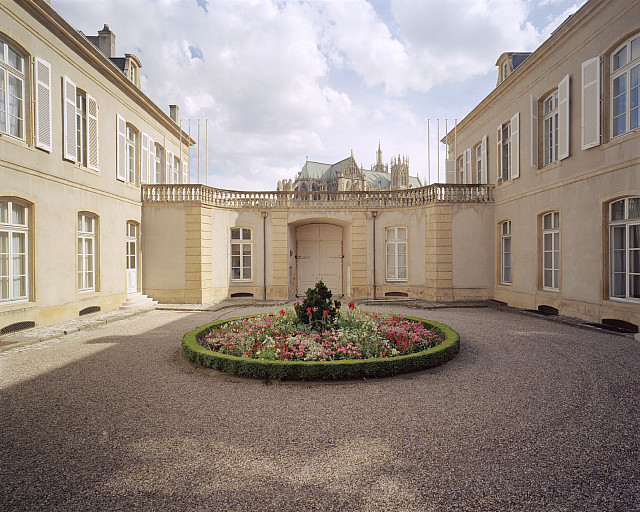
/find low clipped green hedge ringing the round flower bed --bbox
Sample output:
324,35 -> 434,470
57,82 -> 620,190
182,317 -> 460,380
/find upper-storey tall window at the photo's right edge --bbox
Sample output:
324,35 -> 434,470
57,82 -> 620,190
611,35 -> 640,137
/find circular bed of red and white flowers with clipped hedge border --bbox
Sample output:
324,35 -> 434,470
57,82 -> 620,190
182,303 -> 459,380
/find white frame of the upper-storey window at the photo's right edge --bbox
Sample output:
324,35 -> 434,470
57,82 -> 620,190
609,32 -> 640,139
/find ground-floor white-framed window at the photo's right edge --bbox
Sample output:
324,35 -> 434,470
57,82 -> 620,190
609,197 -> 640,300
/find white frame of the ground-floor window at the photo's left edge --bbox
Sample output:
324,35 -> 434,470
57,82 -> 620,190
0,197 -> 31,305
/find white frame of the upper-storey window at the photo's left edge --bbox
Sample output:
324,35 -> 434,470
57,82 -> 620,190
0,35 -> 29,142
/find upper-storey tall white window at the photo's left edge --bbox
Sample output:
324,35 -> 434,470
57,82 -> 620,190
0,39 -> 25,140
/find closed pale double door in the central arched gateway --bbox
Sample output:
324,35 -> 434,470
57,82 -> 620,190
296,224 -> 342,296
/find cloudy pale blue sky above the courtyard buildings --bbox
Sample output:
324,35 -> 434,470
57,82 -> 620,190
51,0 -> 584,190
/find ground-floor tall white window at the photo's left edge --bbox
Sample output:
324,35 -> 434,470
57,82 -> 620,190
0,199 -> 29,302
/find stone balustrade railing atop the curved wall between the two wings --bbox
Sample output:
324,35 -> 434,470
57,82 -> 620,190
142,183 -> 493,209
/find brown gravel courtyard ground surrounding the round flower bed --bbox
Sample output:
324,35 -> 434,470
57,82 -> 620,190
0,307 -> 640,511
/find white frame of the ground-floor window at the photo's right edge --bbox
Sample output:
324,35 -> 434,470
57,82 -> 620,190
607,196 -> 640,303
